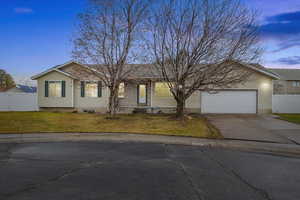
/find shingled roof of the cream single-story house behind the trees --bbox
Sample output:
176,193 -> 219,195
32,61 -> 279,80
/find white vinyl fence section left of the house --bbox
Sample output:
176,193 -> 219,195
0,93 -> 38,111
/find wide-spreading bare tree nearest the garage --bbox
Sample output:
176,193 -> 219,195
145,0 -> 260,118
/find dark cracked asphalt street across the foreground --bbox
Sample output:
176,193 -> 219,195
0,142 -> 300,200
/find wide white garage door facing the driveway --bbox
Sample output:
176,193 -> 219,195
201,90 -> 257,114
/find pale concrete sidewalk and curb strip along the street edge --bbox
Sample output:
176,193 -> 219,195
0,133 -> 300,155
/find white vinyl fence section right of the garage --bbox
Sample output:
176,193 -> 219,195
272,95 -> 300,113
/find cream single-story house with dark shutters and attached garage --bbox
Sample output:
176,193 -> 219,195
32,61 -> 278,113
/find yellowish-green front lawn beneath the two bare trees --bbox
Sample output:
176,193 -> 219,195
0,112 -> 222,138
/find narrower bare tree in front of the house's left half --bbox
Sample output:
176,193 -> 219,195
73,0 -> 148,117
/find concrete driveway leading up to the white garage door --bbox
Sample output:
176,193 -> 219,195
207,115 -> 300,144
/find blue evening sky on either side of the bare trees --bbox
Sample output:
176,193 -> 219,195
0,0 -> 300,83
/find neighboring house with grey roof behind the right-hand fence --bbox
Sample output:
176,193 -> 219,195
269,69 -> 300,94
